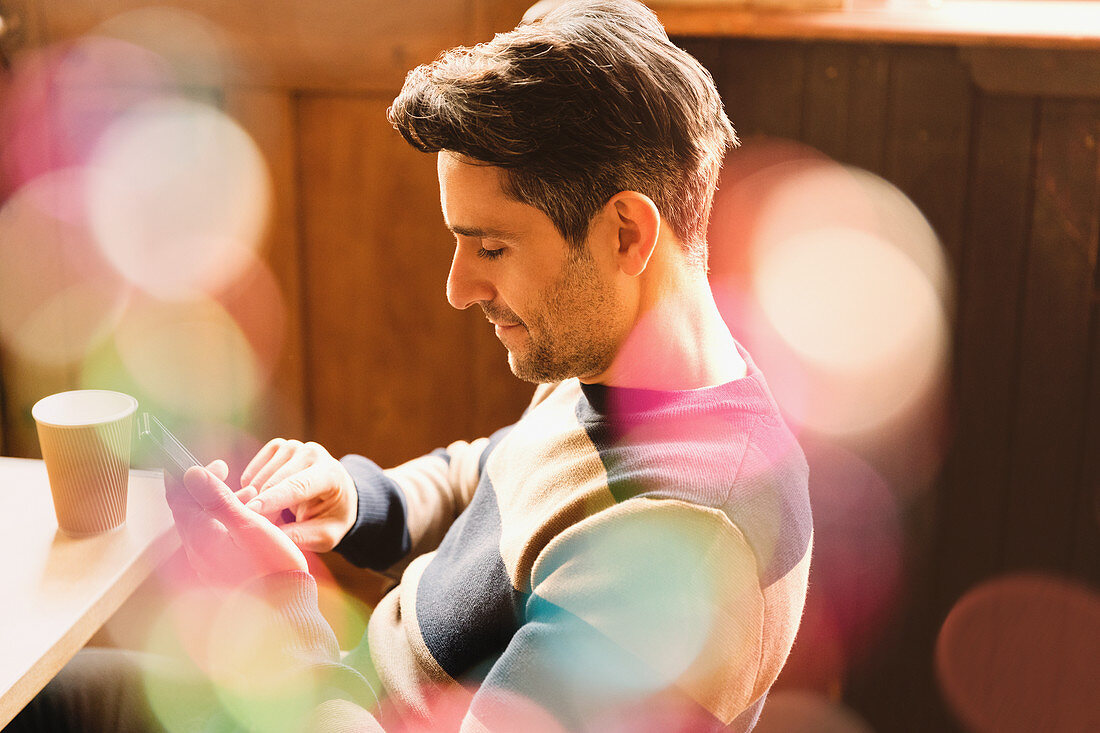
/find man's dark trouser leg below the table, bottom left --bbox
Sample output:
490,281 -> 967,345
3,648 -> 234,733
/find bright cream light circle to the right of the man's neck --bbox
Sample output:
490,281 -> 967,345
755,224 -> 947,435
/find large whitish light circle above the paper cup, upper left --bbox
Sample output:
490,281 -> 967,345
87,99 -> 272,299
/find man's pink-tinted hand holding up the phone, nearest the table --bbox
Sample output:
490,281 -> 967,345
165,461 -> 308,586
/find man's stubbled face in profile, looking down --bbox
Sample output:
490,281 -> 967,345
437,151 -> 629,382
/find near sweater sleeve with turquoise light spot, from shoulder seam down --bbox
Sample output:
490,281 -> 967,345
462,499 -> 770,733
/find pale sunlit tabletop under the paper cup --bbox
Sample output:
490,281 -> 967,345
0,458 -> 179,727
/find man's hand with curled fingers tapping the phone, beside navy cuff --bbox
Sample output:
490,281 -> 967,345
241,438 -> 359,553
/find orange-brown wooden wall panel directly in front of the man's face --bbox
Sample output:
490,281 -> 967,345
298,96 -> 484,464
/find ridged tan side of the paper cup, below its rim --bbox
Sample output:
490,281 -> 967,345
39,413 -> 133,535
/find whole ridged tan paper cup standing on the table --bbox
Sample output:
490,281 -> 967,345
31,390 -> 138,537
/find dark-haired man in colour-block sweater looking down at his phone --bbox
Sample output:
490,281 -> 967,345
10,0 -> 812,731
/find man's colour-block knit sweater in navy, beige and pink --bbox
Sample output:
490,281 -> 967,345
255,351 -> 813,731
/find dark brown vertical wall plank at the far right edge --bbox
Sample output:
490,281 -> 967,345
1003,99 -> 1100,572
